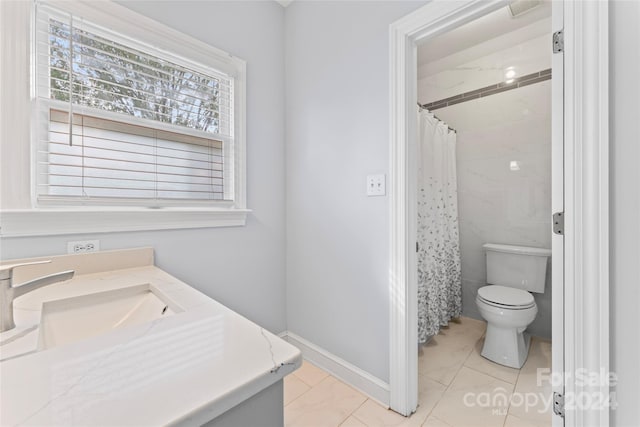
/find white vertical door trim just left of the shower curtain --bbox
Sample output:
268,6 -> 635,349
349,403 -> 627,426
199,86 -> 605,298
389,9 -> 422,416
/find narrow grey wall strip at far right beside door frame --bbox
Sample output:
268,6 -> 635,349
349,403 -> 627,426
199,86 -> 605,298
609,1 -> 640,427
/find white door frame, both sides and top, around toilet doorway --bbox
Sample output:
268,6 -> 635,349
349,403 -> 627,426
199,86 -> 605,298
389,0 -> 609,426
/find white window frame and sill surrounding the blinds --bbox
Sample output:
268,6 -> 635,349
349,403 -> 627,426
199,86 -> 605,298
0,0 -> 250,237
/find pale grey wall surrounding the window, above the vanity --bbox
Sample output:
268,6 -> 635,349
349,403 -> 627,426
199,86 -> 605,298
0,1 -> 286,332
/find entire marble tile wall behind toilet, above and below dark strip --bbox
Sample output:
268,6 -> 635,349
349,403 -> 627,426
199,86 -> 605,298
418,15 -> 551,338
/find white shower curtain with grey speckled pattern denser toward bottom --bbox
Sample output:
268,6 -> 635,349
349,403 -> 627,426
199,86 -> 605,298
418,110 -> 462,343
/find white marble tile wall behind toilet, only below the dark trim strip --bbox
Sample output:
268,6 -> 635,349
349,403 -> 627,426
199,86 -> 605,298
436,81 -> 551,338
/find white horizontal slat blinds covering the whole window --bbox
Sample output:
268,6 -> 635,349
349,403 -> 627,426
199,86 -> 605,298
35,5 -> 234,206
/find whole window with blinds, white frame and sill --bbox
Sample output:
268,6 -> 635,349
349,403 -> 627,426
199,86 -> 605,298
0,0 -> 249,237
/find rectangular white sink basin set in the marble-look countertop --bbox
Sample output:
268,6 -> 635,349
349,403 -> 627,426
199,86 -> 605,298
38,284 -> 182,350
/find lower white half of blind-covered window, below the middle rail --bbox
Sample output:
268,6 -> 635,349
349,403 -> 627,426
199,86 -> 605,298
39,110 -> 224,200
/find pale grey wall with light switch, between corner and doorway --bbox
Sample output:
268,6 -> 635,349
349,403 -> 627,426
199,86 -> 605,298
285,1 -> 423,381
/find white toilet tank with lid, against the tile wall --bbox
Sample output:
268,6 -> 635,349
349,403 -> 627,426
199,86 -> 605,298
482,243 -> 551,293
